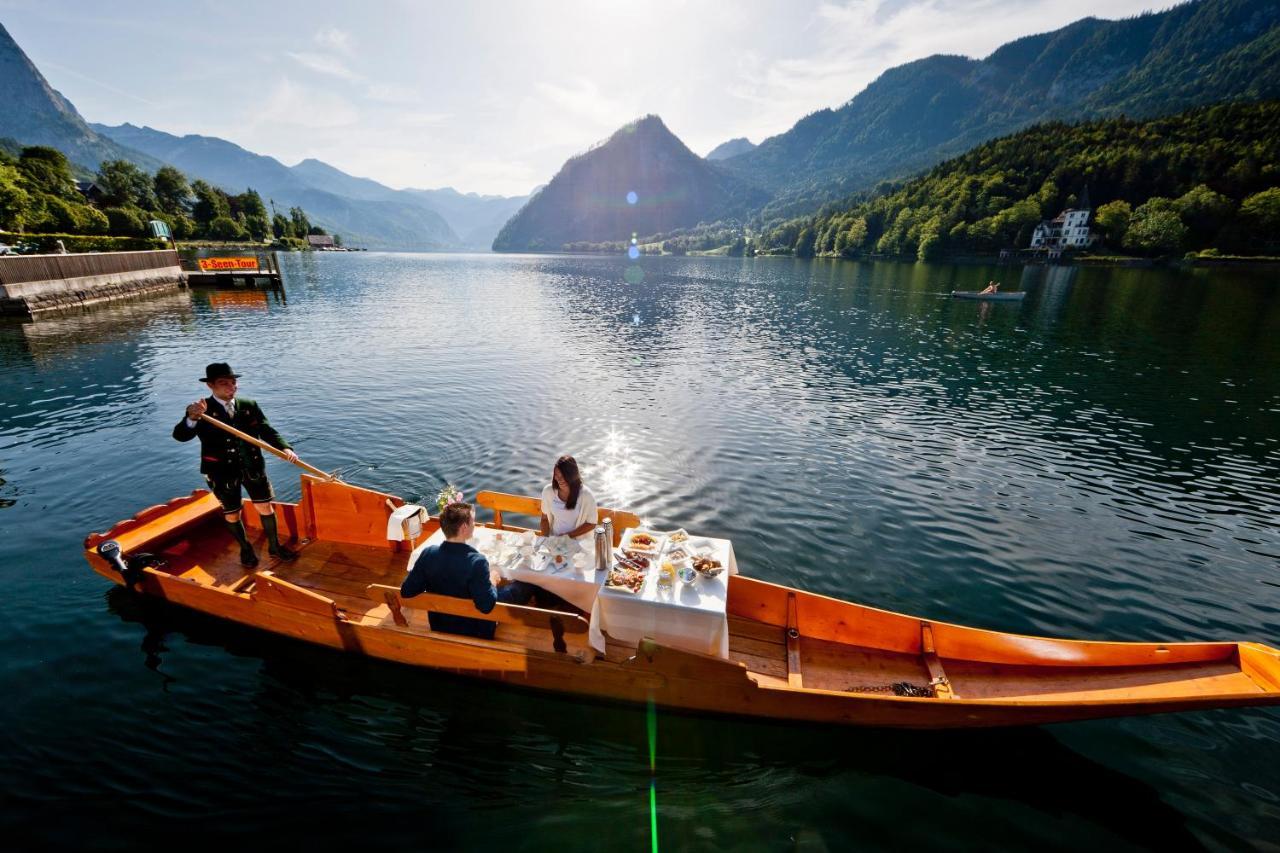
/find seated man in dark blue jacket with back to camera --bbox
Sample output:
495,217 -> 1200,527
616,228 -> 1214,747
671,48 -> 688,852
401,502 -> 538,639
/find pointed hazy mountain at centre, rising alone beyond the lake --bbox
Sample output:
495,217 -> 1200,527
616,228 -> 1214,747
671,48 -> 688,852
493,115 -> 767,251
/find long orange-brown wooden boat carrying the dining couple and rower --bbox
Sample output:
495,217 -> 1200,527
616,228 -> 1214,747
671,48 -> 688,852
84,475 -> 1280,729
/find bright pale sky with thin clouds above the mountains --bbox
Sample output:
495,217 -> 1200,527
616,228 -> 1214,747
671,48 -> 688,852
0,0 -> 1171,196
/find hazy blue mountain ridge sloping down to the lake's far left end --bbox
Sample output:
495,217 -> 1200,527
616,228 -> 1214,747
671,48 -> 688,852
92,124 -> 461,250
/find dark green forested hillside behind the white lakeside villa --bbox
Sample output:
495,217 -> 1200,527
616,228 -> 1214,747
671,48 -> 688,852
754,101 -> 1280,259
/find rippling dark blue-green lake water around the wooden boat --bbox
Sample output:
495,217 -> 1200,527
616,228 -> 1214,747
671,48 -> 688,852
0,254 -> 1280,850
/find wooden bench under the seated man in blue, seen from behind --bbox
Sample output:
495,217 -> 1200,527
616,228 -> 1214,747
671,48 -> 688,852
366,584 -> 595,662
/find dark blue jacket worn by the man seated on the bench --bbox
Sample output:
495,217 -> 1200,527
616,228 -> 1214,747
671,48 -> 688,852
401,542 -> 498,639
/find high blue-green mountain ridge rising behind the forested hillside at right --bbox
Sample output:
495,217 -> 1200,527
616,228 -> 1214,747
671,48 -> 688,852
723,0 -> 1280,209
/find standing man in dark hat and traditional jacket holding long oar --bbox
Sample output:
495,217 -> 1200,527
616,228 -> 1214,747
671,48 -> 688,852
173,361 -> 298,567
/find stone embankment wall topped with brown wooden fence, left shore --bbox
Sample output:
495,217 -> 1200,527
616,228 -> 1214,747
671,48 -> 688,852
0,250 -> 186,318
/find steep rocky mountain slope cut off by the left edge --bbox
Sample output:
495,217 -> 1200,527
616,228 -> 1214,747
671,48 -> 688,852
0,24 -> 164,172
